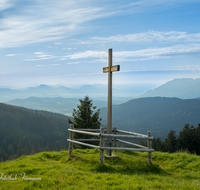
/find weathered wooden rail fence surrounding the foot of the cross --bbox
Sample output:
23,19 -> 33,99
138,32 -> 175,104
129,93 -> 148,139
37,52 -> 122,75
67,124 -> 154,165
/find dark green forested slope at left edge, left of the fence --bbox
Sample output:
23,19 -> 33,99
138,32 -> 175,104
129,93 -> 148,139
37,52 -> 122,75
0,103 -> 69,160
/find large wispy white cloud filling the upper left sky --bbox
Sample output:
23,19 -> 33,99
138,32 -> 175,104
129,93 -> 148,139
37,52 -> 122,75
0,0 -> 113,48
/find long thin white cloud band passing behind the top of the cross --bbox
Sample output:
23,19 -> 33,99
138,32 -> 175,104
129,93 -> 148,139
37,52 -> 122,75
25,44 -> 200,65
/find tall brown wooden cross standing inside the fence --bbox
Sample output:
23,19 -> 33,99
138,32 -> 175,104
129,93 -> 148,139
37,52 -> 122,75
103,49 -> 120,156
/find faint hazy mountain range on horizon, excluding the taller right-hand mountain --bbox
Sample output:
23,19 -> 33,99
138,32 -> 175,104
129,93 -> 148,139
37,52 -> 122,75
0,84 -> 155,102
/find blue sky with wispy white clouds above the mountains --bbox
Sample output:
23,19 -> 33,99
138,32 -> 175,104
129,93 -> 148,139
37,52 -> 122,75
0,0 -> 200,88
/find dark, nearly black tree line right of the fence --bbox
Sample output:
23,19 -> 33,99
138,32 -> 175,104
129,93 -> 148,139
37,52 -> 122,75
152,123 -> 200,155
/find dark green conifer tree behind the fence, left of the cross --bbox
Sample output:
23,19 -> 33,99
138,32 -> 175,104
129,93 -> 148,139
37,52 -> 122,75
68,96 -> 101,147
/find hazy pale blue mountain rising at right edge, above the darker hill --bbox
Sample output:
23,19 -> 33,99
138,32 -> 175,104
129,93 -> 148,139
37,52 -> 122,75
140,78 -> 200,99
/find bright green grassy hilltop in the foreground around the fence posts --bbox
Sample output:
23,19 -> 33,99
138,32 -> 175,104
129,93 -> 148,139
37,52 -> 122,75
0,149 -> 200,190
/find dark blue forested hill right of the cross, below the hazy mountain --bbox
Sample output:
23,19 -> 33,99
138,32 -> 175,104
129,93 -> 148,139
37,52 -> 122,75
100,97 -> 200,140
